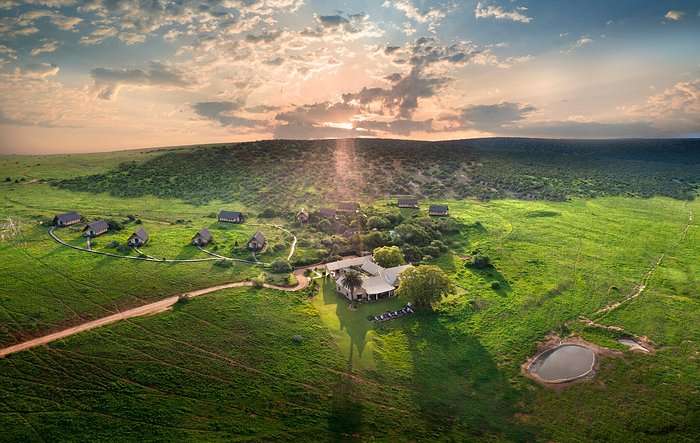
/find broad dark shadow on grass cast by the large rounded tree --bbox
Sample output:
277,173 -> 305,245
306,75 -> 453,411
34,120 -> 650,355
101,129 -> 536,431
405,312 -> 535,441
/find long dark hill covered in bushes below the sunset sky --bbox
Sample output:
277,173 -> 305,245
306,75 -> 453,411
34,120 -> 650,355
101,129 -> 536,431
54,138 -> 700,208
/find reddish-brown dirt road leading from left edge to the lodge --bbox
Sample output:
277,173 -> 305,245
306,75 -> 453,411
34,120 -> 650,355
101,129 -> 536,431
0,267 -> 310,358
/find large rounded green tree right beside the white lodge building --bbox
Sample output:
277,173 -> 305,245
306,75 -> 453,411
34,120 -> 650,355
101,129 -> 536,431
396,265 -> 454,309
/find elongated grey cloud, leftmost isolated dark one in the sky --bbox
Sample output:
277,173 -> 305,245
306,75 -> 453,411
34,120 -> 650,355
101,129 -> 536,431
90,62 -> 195,100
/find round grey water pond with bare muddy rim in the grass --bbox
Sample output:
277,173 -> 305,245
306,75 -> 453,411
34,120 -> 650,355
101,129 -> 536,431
530,345 -> 595,383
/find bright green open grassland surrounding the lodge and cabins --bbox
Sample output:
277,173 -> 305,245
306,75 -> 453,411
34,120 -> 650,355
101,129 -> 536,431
0,142 -> 700,442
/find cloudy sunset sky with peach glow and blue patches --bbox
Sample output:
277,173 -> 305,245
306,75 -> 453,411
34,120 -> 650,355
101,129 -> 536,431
0,0 -> 700,153
